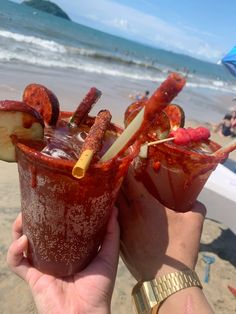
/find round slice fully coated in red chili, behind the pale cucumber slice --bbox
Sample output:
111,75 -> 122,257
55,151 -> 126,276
22,83 -> 60,126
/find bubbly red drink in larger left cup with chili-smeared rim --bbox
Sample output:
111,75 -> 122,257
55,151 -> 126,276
17,113 -> 133,277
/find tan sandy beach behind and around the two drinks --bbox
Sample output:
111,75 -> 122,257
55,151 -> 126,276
0,65 -> 236,314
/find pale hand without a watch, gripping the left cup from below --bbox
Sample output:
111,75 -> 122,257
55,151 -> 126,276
7,208 -> 120,314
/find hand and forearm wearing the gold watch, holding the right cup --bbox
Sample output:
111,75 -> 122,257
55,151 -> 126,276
118,169 -> 213,314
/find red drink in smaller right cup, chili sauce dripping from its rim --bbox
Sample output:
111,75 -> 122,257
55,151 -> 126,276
132,140 -> 226,212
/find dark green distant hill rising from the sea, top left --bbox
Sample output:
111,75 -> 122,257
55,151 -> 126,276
21,0 -> 71,21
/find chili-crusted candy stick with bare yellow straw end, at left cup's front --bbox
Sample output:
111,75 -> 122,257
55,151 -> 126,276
72,110 -> 111,179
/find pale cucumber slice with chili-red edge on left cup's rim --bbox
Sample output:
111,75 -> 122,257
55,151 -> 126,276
0,100 -> 44,162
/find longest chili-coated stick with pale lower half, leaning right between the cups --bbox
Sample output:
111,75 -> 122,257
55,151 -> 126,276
100,73 -> 186,161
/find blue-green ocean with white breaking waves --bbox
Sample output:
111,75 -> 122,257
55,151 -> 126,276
0,0 -> 236,120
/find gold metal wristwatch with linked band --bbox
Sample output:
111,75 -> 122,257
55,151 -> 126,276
132,269 -> 202,314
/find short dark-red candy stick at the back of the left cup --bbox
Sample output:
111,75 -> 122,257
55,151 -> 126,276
68,87 -> 102,128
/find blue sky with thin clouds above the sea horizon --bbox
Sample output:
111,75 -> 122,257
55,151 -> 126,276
13,0 -> 236,62
